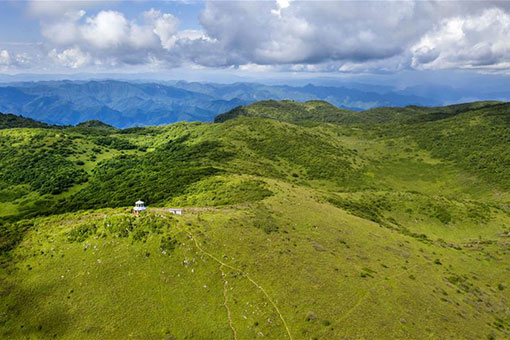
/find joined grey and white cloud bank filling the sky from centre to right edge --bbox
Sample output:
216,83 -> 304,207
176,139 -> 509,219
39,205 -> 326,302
193,0 -> 510,72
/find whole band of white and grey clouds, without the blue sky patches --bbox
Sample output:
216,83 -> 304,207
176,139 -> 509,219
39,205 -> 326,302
0,0 -> 510,72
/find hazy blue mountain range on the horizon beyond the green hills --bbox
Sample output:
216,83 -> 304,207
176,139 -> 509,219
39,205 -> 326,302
0,80 -> 440,128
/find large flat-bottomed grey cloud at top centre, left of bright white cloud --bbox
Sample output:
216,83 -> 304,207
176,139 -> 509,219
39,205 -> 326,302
201,1 -> 422,64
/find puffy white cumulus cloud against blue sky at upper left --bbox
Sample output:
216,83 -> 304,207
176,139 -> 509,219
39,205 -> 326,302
42,9 -> 198,68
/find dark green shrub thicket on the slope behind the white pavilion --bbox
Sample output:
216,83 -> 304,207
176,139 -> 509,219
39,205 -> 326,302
59,139 -> 229,211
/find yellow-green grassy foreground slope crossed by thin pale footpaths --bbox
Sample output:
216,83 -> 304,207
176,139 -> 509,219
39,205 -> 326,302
2,181 -> 509,339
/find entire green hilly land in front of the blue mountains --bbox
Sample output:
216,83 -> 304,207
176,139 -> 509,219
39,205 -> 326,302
0,102 -> 510,339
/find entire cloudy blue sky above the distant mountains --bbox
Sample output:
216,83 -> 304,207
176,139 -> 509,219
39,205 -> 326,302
0,0 -> 510,87
